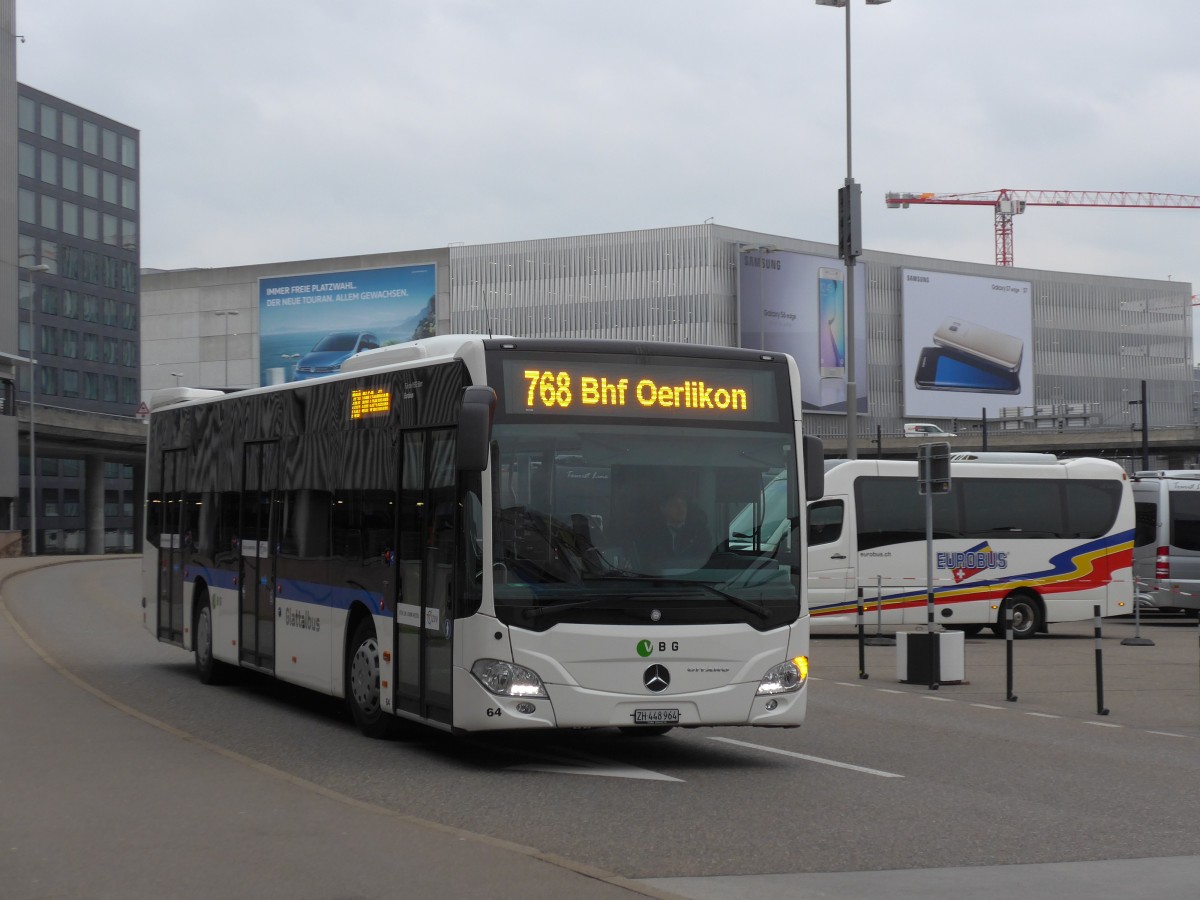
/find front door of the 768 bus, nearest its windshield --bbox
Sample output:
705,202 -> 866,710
395,428 -> 457,725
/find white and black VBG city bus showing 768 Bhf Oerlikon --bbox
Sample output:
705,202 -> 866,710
143,336 -> 822,736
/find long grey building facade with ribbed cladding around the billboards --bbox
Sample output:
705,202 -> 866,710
143,224 -> 1196,464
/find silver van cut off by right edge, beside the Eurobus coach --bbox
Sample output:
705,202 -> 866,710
1133,469 -> 1200,614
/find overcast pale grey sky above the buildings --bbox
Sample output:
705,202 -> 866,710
17,0 -> 1200,303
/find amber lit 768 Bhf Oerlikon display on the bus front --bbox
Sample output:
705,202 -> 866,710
504,360 -> 778,421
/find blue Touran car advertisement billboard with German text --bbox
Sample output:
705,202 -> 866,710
258,263 -> 438,384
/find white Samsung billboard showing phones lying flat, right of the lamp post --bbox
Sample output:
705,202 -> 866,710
901,269 -> 1033,419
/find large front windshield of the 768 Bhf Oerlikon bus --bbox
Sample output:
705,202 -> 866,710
492,422 -> 800,630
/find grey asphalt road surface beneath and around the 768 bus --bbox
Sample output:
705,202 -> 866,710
0,558 -> 1200,900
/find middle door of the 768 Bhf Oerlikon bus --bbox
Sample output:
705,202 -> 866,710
238,440 -> 280,672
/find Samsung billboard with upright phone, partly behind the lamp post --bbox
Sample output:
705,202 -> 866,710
738,251 -> 866,413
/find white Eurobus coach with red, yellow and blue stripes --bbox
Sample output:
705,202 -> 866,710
808,458 -> 1134,637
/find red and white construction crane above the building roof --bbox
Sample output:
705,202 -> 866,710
887,187 -> 1200,265
